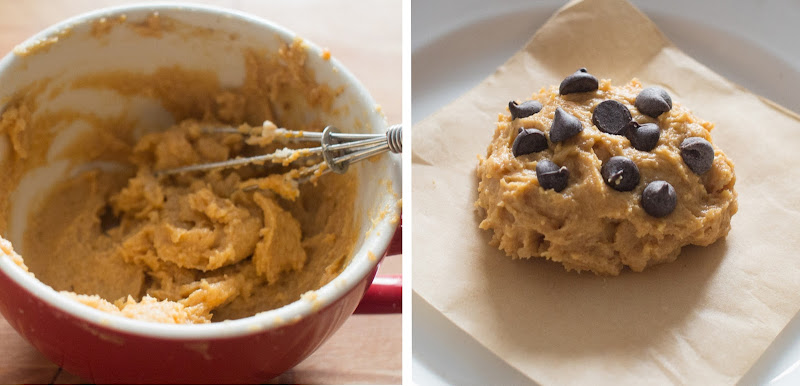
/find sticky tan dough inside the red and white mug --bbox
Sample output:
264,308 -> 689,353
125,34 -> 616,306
0,34 -> 358,323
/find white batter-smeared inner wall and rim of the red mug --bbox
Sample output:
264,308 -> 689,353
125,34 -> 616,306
0,4 -> 401,338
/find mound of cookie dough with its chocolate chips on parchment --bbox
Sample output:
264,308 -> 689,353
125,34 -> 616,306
476,69 -> 737,275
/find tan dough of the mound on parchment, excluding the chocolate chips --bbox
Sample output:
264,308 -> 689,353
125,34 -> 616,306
476,79 -> 737,275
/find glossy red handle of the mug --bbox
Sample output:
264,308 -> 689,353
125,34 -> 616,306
355,223 -> 403,314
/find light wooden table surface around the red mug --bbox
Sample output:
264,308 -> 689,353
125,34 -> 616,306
0,0 -> 402,384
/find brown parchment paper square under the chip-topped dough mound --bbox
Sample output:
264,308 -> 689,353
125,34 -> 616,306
412,0 -> 800,384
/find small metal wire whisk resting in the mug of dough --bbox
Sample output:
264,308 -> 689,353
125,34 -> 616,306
155,124 -> 403,183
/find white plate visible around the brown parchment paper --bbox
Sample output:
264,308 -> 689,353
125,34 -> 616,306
411,0 -> 800,385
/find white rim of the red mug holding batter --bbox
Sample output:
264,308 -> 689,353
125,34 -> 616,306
0,2 -> 402,340
